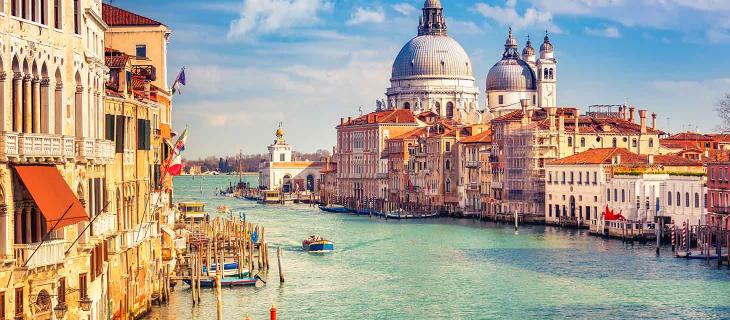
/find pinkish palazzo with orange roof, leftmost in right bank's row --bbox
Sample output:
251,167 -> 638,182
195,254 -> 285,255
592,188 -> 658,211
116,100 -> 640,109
335,109 -> 423,201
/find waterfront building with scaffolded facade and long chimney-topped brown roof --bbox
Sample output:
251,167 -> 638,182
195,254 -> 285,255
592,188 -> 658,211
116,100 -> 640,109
491,104 -> 662,217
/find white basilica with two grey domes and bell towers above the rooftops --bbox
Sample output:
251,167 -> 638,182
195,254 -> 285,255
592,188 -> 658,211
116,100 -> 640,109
383,0 -> 556,124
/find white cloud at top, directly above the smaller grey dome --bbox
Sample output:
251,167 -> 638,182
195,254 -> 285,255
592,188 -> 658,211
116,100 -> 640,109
474,0 -> 561,33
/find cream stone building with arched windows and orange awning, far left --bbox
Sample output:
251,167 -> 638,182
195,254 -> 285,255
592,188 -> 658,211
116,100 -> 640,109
0,0 -> 114,319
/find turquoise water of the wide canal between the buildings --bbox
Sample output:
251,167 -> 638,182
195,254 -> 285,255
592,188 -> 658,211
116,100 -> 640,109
152,176 -> 730,319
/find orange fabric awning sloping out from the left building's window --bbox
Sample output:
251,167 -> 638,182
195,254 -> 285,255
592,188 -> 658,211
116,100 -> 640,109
15,166 -> 89,232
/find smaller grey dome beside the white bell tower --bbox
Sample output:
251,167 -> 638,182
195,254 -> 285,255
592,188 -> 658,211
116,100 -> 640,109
487,59 -> 537,91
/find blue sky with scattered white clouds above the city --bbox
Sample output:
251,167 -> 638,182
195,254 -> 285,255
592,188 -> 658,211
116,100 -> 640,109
114,0 -> 730,158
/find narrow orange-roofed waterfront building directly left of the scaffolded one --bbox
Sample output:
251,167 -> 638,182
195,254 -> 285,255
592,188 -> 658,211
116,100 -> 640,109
458,126 -> 492,215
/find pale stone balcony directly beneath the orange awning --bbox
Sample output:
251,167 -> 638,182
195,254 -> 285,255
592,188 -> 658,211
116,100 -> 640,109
14,239 -> 66,269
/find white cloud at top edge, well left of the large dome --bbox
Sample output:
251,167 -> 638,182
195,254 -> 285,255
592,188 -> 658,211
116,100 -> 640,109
228,0 -> 333,38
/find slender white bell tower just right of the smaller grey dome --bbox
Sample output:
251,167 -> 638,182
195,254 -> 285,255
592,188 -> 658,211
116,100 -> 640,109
536,31 -> 558,108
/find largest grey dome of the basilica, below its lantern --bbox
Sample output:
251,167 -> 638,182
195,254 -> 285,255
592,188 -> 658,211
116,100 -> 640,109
392,34 -> 474,80
